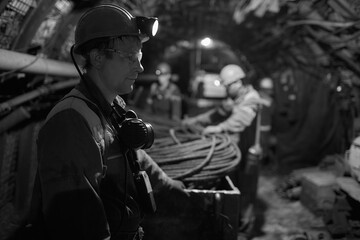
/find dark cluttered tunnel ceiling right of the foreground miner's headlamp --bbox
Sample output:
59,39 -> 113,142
81,0 -> 360,79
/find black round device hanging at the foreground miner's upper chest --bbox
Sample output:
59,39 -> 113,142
111,104 -> 154,149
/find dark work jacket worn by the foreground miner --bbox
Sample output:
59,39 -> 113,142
28,76 -> 172,239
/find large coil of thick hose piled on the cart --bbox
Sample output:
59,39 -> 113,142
142,111 -> 241,188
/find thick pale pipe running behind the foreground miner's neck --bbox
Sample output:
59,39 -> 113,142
0,49 -> 78,77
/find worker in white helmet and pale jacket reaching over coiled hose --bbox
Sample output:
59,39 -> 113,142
182,64 -> 263,238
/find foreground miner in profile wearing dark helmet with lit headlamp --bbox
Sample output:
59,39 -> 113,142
26,4 -> 184,240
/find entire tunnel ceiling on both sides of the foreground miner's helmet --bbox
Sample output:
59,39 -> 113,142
0,0 -> 360,83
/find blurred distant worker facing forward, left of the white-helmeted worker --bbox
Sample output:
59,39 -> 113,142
147,62 -> 181,120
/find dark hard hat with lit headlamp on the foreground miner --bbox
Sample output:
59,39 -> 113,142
74,4 -> 158,53
